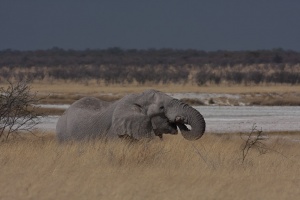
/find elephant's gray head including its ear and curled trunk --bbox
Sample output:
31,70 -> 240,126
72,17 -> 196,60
112,90 -> 205,140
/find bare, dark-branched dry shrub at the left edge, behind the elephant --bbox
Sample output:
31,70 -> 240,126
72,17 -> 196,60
0,81 -> 40,139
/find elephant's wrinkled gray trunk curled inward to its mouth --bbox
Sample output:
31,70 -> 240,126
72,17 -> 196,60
168,100 -> 205,140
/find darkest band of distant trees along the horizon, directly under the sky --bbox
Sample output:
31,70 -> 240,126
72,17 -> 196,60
0,47 -> 300,67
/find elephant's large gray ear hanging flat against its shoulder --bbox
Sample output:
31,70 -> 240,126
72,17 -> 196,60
111,103 -> 154,140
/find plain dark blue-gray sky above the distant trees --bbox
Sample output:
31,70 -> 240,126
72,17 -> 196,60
0,0 -> 300,51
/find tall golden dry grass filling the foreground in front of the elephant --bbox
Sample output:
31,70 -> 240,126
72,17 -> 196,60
0,134 -> 300,200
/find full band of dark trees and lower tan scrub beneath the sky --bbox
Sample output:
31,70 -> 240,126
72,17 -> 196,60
0,47 -> 300,85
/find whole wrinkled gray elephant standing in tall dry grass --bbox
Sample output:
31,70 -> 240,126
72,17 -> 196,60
56,90 -> 205,141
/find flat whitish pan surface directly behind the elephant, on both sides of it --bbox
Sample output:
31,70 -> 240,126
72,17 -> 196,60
37,105 -> 300,133
